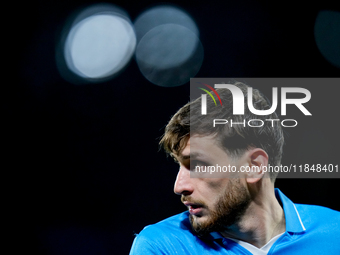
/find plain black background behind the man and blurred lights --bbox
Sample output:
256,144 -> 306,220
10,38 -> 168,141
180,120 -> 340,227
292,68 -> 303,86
2,0 -> 340,254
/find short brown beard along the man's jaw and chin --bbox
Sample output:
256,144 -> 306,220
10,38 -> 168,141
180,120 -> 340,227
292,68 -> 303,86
189,179 -> 251,236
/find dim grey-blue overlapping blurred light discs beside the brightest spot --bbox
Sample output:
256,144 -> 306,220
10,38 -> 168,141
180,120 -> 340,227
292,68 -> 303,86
134,6 -> 204,87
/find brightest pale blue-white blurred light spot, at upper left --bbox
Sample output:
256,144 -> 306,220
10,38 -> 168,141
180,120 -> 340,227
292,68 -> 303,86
57,5 -> 136,82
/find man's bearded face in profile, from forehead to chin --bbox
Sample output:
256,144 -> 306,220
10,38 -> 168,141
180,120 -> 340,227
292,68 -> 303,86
174,136 -> 250,235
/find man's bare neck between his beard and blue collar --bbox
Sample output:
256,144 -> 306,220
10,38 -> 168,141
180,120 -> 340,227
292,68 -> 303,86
221,188 -> 286,248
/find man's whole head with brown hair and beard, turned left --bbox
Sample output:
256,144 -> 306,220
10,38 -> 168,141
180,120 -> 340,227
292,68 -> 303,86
160,83 -> 284,235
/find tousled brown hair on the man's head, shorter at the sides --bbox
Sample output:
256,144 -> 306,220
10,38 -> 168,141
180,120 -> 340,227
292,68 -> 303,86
160,82 -> 284,182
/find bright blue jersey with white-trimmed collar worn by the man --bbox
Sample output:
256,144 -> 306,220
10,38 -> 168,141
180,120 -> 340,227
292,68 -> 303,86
130,189 -> 340,255
